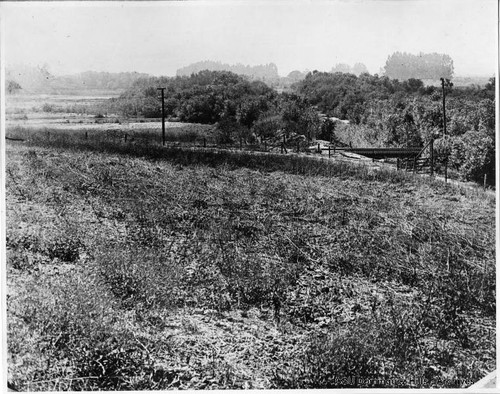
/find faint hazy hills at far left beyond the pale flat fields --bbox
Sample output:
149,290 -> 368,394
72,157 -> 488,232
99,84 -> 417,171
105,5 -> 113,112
5,65 -> 149,94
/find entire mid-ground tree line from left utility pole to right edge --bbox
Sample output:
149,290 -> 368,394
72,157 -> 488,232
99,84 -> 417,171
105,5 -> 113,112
111,70 -> 495,185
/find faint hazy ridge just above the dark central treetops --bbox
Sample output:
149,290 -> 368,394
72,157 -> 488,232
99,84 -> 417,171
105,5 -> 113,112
177,60 -> 280,82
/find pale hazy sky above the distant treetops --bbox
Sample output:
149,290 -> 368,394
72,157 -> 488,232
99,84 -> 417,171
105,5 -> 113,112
0,0 -> 498,76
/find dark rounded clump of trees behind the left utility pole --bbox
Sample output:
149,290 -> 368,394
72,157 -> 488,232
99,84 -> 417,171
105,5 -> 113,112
112,70 -> 320,142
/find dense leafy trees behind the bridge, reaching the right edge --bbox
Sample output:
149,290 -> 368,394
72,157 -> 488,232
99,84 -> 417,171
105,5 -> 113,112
296,72 -> 495,181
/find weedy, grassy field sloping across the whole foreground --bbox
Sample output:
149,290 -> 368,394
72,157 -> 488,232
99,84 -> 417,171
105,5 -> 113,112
6,129 -> 495,391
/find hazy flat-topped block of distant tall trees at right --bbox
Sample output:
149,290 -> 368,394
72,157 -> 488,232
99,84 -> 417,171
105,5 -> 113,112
384,52 -> 453,81
